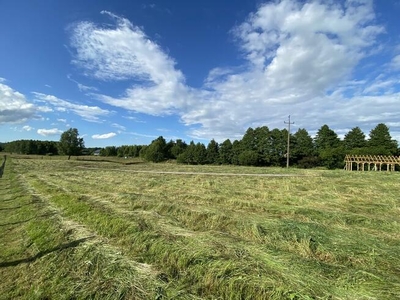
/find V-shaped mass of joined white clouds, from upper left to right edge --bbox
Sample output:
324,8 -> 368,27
71,0 -> 400,140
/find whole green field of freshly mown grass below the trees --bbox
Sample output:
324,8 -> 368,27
0,157 -> 400,300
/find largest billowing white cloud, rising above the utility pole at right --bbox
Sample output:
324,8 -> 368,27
182,0 -> 384,139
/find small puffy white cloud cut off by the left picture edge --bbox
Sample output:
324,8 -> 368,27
0,83 -> 36,124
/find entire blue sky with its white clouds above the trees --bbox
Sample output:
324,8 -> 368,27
0,0 -> 400,147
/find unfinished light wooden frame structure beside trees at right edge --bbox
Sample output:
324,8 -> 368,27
344,155 -> 400,172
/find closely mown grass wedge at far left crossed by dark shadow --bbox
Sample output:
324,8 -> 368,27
0,161 -> 162,299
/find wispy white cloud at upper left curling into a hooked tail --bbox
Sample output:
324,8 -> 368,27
71,12 -> 187,115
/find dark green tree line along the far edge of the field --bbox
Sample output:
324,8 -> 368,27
0,123 -> 400,169
